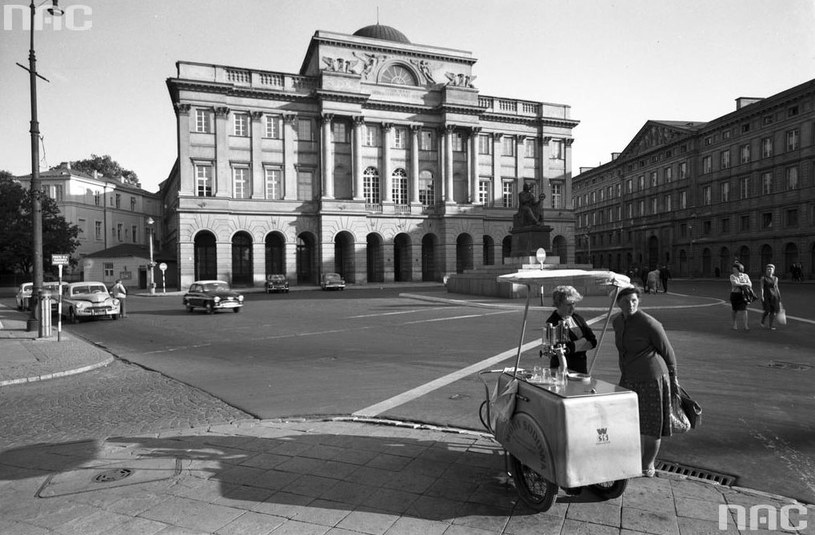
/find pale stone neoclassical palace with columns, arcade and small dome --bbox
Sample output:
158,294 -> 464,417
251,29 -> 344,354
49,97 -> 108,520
160,24 -> 578,287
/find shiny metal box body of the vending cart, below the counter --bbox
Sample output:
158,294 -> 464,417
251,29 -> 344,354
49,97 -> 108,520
495,373 -> 642,487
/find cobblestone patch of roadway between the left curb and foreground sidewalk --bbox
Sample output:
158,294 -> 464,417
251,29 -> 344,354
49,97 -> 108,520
0,360 -> 253,450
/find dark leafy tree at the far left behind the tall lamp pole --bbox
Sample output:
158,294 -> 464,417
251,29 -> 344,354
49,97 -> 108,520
0,176 -> 80,273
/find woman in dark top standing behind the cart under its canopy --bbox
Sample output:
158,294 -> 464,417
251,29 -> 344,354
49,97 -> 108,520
546,286 -> 597,373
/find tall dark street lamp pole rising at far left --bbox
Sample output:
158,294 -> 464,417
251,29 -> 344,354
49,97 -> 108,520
17,0 -> 63,337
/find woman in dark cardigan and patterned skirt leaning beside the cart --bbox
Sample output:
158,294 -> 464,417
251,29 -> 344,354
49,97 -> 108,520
613,287 -> 679,477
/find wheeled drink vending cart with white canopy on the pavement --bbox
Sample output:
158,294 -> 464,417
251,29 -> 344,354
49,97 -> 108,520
481,269 -> 642,511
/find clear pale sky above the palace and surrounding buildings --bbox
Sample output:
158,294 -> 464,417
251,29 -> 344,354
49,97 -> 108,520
0,0 -> 815,192
